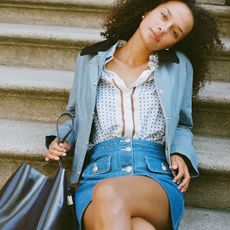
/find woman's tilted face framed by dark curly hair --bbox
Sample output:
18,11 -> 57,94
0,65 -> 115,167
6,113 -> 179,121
139,1 -> 193,51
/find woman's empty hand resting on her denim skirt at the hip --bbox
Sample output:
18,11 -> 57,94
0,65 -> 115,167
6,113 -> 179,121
170,155 -> 190,192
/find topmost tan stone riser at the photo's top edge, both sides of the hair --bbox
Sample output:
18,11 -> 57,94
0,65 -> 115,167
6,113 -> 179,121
0,0 -> 230,36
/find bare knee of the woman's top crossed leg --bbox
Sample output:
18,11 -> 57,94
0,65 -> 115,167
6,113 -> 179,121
92,179 -> 125,215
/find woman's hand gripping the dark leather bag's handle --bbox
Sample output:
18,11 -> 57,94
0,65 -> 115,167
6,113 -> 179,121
45,139 -> 71,161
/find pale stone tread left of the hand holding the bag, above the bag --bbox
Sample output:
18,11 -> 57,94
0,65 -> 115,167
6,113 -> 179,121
0,119 -> 52,160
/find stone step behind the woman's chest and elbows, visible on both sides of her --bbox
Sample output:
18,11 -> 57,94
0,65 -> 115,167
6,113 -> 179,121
0,66 -> 230,137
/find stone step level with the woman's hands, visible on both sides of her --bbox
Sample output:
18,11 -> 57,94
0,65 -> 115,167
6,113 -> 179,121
0,119 -> 230,209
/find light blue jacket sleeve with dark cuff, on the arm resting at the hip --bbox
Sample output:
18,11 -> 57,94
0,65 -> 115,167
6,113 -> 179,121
170,60 -> 199,178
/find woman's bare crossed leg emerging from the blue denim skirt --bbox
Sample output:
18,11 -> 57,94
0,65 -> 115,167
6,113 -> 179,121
84,176 -> 170,230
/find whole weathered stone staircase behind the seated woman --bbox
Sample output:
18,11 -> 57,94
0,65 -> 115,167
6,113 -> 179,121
0,0 -> 230,230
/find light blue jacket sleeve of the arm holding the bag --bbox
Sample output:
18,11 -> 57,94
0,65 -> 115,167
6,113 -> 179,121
45,55 -> 80,152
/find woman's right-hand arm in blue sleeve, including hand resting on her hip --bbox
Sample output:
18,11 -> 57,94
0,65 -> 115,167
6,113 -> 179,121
171,57 -> 199,189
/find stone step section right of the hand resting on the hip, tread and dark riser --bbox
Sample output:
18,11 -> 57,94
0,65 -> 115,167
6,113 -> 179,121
185,135 -> 230,211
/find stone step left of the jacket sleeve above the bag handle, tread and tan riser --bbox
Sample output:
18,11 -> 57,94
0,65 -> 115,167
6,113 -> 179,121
0,66 -> 73,121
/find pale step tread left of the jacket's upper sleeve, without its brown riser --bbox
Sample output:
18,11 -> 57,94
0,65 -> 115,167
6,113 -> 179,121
0,66 -> 74,96
